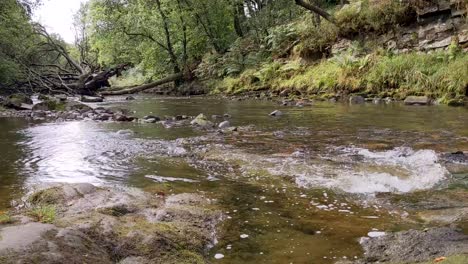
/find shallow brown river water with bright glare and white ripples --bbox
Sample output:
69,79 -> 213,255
0,97 -> 468,263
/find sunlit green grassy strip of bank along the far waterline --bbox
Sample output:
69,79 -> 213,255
211,48 -> 468,103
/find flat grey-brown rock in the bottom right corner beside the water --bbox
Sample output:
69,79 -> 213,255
357,227 -> 468,263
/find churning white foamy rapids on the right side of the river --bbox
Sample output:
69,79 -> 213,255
288,148 -> 448,193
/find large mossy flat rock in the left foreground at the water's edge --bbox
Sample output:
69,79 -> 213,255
0,184 -> 221,263
